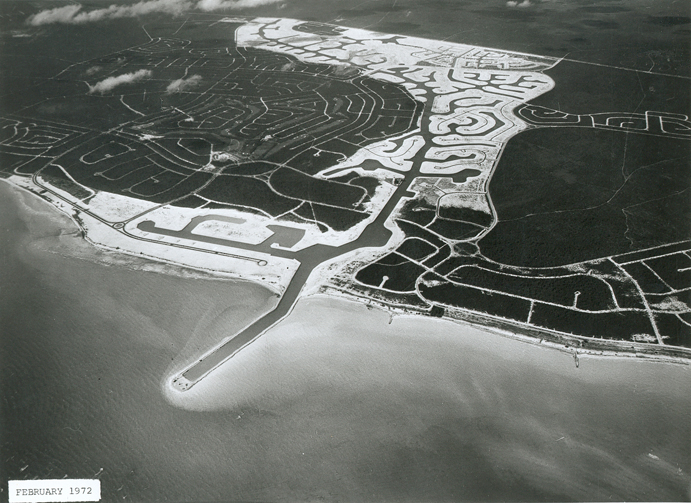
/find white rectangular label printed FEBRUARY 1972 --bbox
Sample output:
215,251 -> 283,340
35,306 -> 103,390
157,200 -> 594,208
7,479 -> 101,503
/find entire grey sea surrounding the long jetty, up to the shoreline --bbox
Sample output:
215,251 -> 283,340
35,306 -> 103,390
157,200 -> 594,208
0,184 -> 691,502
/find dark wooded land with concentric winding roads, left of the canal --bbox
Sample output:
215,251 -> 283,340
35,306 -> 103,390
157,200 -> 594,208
0,30 -> 422,236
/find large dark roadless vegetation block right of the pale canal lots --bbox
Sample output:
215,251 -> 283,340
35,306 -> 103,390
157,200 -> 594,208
480,127 -> 691,267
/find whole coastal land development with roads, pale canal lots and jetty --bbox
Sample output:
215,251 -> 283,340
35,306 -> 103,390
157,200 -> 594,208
0,17 -> 691,391
